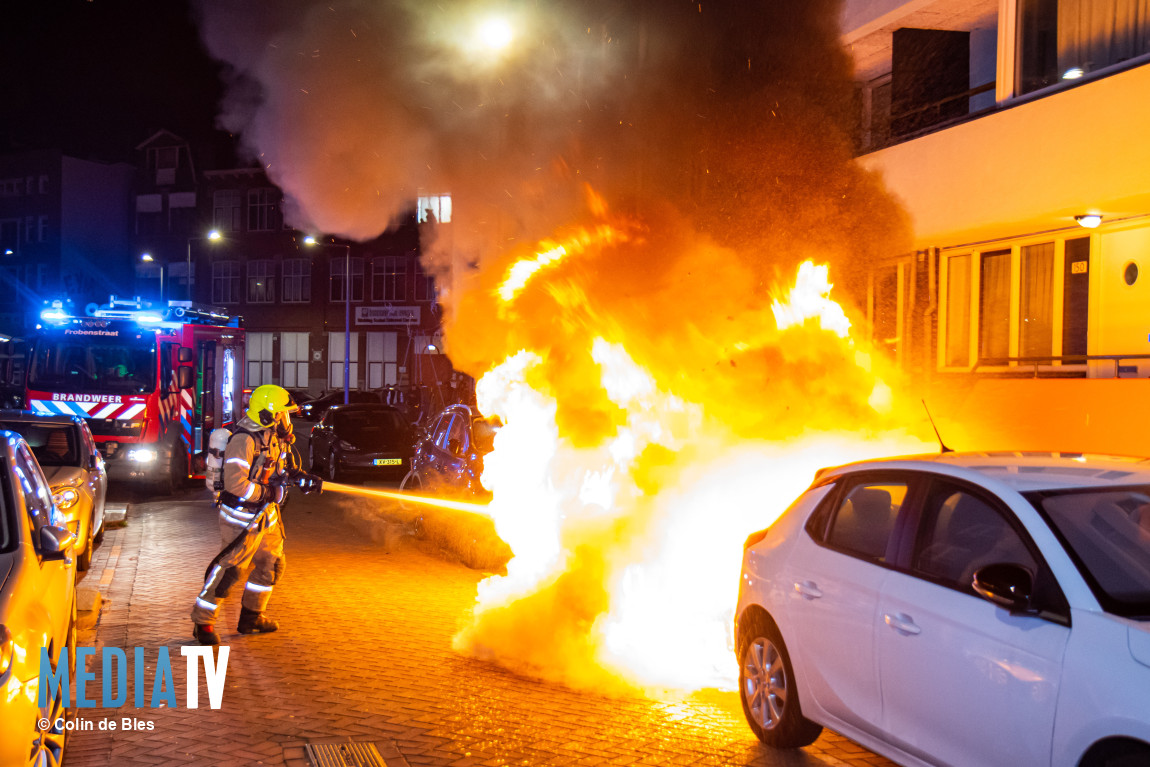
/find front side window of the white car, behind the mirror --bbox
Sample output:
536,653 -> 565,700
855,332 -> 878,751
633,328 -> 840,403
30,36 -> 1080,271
912,482 -> 1038,592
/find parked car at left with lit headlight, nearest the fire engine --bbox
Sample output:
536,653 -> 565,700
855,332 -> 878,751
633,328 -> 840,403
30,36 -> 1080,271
0,411 -> 108,573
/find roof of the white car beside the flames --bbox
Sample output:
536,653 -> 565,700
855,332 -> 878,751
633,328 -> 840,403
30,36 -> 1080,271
819,452 -> 1150,492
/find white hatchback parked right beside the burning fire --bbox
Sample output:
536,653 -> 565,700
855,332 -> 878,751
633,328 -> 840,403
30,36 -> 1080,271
735,453 -> 1150,767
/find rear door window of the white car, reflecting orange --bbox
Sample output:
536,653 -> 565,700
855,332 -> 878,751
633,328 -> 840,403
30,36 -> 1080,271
827,481 -> 907,562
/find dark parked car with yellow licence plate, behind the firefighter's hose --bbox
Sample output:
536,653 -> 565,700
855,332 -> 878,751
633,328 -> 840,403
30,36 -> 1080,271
307,404 -> 415,482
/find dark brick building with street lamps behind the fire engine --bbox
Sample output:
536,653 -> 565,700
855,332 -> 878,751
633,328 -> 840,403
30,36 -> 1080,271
135,131 -> 452,402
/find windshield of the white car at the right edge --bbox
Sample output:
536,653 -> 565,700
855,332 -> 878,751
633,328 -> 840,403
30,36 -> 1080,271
1027,485 -> 1150,618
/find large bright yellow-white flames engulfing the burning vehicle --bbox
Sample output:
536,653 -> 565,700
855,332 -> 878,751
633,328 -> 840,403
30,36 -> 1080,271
443,196 -> 930,690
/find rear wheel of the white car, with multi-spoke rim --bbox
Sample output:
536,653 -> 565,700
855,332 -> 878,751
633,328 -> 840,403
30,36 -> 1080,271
738,618 -> 822,749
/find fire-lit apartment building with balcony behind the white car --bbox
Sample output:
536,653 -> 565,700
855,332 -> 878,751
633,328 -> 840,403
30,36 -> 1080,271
842,0 -> 1150,454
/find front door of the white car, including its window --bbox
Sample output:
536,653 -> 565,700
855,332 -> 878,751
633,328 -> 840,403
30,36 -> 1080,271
876,478 -> 1070,767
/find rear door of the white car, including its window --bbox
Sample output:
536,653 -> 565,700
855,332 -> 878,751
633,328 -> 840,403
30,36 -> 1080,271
781,473 -> 914,733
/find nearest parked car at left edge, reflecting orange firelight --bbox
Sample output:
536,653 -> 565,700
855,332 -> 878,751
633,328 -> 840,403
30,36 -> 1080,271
0,430 -> 76,767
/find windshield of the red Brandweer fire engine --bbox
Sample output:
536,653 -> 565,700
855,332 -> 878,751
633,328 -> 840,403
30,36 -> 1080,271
28,331 -> 155,394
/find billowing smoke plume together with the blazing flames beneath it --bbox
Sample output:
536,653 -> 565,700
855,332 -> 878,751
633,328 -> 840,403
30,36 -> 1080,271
190,0 -> 920,689
